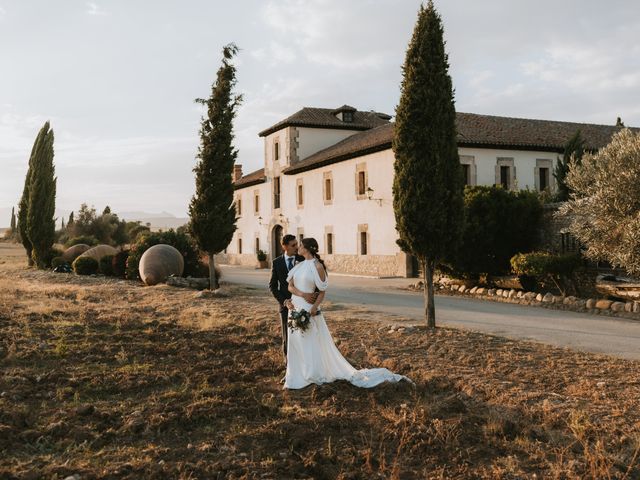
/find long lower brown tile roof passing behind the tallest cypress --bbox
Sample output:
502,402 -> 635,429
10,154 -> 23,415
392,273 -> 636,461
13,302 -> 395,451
284,112 -> 640,175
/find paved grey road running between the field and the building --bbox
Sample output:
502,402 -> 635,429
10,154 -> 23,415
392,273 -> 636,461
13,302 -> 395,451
222,266 -> 640,360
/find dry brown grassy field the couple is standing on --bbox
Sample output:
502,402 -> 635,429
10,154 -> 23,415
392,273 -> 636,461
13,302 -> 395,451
0,244 -> 640,479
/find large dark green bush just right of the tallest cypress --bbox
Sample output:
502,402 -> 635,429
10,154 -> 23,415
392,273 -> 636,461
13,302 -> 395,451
443,186 -> 542,279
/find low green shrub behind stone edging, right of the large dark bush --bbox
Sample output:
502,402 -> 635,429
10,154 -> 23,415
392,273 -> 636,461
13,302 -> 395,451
511,252 -> 583,295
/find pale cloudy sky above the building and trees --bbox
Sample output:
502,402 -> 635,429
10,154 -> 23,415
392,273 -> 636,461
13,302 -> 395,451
0,0 -> 640,221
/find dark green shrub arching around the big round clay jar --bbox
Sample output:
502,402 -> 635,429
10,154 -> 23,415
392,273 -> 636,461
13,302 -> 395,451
126,229 -> 202,280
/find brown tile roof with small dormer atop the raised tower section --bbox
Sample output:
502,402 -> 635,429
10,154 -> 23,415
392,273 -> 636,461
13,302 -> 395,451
259,105 -> 391,137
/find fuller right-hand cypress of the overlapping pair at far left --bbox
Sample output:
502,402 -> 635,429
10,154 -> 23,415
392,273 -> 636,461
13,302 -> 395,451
27,122 -> 56,268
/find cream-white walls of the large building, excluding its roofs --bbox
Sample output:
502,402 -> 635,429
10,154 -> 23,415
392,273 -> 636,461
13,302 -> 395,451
220,111 -> 557,276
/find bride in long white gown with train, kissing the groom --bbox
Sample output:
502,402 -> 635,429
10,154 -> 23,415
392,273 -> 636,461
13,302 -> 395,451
284,238 -> 413,389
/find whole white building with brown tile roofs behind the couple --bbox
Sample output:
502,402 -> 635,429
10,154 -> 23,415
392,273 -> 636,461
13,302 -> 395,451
219,105 -> 619,277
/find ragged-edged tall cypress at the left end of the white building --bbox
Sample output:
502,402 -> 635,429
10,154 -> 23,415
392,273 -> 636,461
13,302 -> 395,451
189,44 -> 242,290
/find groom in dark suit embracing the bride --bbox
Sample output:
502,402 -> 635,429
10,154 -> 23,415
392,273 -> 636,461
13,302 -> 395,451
269,235 -> 315,365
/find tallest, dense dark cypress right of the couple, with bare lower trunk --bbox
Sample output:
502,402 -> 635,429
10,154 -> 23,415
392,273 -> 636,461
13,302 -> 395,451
393,0 -> 463,328
